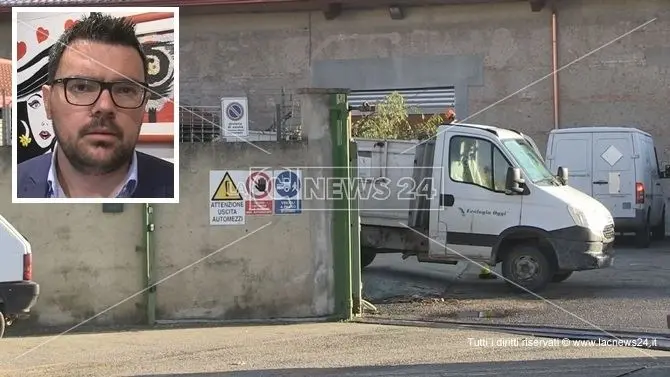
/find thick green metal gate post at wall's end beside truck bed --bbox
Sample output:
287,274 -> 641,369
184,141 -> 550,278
329,93 -> 353,320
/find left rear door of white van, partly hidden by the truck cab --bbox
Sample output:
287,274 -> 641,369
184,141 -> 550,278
549,132 -> 593,195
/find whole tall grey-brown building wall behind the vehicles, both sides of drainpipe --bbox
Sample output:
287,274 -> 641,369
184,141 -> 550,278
180,0 -> 670,160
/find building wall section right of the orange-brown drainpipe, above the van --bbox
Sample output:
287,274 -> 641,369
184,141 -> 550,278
558,0 -> 670,161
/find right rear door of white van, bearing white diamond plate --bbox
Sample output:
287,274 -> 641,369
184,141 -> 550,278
592,132 -> 639,217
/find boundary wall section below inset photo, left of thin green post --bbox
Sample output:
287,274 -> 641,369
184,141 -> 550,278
0,151 -> 143,325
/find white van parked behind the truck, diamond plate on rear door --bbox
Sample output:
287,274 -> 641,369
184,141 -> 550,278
546,126 -> 665,247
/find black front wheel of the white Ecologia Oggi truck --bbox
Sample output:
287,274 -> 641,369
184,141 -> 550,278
502,245 -> 555,292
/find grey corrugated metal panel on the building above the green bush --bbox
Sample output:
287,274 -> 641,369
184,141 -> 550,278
349,87 -> 456,110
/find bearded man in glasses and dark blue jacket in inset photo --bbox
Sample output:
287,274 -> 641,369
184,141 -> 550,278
17,13 -> 175,198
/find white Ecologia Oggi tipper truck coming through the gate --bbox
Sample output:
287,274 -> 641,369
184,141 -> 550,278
355,124 -> 614,292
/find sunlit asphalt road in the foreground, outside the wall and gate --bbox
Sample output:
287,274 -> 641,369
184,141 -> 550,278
0,323 -> 670,377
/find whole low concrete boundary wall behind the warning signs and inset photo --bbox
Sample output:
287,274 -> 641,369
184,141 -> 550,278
0,92 -> 334,326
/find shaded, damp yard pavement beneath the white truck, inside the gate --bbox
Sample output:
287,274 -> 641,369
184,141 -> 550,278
363,237 -> 670,333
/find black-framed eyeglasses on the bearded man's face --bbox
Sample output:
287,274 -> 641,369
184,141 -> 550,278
53,77 -> 149,109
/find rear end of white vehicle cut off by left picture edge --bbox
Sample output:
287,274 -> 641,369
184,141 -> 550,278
0,215 -> 40,338
